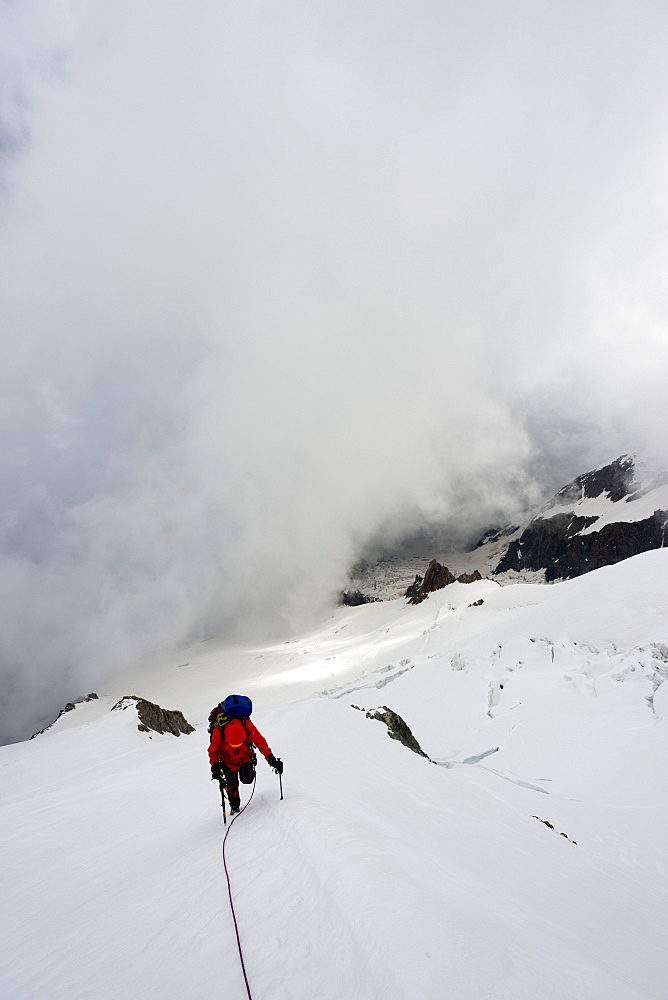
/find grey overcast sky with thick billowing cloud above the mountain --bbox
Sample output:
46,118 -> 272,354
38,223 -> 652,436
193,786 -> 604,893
0,0 -> 668,739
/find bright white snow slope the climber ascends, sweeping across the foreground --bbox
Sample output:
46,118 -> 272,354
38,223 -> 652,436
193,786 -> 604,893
0,549 -> 668,1000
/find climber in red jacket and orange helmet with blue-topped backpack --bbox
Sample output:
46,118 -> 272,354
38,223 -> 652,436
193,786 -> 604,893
209,695 -> 283,813
